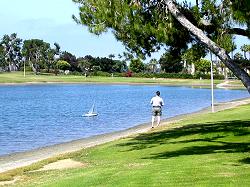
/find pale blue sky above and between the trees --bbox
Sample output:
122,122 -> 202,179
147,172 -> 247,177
0,0 -> 249,61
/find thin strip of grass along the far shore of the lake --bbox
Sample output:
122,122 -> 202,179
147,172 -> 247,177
0,72 -> 229,86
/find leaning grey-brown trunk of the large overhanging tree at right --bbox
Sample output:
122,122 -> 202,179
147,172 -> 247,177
165,0 -> 250,93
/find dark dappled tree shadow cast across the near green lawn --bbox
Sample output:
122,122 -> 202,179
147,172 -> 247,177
118,120 -> 250,159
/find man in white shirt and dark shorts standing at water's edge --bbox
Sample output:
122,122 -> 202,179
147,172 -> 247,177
150,91 -> 164,128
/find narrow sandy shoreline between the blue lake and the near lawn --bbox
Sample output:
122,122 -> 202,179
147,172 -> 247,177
0,98 -> 250,173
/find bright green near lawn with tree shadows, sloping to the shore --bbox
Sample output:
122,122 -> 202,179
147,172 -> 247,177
2,105 -> 250,187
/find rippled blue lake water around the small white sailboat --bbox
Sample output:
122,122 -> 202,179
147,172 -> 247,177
0,84 -> 249,155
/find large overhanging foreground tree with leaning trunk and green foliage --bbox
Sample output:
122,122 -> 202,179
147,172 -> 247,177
73,0 -> 250,92
